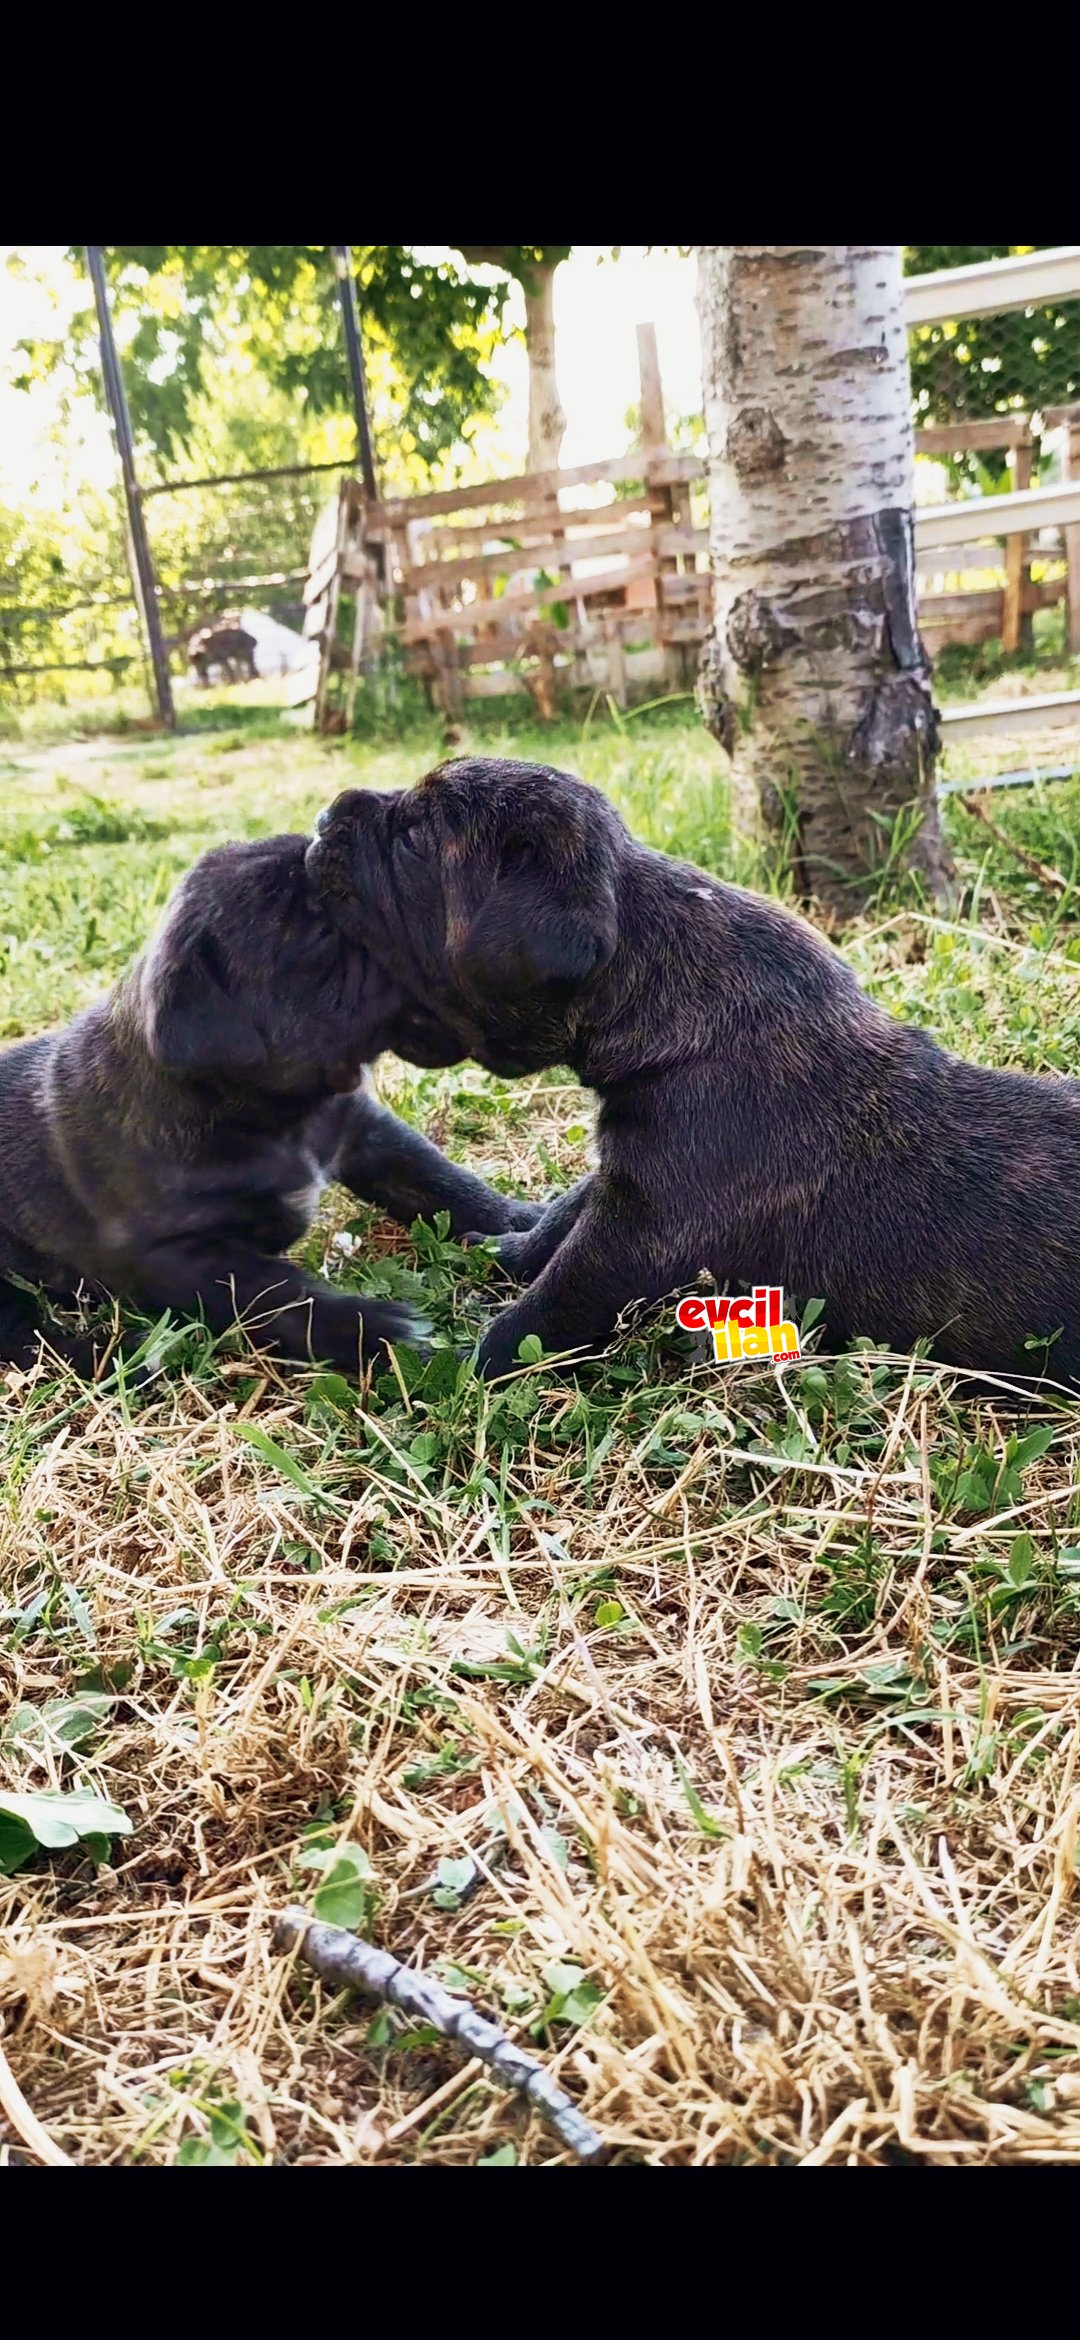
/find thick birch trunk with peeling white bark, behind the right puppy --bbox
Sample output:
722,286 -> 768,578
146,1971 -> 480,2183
699,243 -> 951,917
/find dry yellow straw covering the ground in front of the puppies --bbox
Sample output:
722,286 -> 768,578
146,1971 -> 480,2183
0,1272 -> 1080,2167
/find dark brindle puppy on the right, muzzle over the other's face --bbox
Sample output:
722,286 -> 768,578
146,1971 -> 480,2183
309,761 -> 1080,1381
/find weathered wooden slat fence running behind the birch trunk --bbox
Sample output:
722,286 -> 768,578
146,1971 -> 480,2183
297,266 -> 1080,721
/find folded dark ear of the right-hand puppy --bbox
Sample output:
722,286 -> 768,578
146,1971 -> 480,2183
451,838 -> 617,1004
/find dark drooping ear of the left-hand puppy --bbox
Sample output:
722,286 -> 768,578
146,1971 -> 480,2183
140,929 -> 266,1079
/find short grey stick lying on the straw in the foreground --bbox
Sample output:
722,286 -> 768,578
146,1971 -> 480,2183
274,1909 -> 603,2162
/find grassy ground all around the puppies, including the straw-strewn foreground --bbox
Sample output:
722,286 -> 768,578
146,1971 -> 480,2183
0,709 -> 1080,2165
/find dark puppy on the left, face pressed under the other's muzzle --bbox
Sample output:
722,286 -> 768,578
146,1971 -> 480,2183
0,838 -> 538,1371
